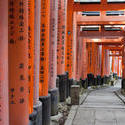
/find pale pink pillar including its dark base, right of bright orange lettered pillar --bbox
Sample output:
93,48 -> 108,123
49,0 -> 58,116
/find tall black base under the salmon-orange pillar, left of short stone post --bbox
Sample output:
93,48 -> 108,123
58,74 -> 67,102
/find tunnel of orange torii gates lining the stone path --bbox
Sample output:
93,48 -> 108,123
0,0 -> 125,125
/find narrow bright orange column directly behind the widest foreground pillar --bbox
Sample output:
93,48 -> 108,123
28,0 -> 34,114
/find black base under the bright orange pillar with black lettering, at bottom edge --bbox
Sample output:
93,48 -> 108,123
39,94 -> 51,125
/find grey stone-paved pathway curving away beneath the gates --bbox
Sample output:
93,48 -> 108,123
72,81 -> 125,125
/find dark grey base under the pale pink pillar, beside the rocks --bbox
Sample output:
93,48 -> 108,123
49,88 -> 59,116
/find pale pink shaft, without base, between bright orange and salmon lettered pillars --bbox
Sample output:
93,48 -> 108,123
49,0 -> 58,90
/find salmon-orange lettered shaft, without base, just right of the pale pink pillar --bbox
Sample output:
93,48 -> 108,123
57,0 -> 67,75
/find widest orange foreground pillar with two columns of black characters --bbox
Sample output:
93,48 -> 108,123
8,0 -> 29,125
